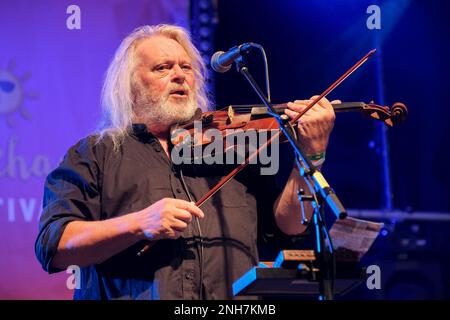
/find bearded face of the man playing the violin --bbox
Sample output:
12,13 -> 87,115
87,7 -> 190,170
135,36 -> 197,126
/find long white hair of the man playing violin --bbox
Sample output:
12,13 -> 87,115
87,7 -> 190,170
98,24 -> 209,148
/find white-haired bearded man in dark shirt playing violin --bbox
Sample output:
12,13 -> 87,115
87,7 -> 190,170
35,25 -> 334,299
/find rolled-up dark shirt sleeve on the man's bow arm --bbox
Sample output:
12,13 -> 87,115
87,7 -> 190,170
35,138 -> 101,273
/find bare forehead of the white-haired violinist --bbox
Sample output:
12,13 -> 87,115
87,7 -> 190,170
136,35 -> 191,61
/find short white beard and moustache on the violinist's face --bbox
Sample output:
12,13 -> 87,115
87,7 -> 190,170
135,86 -> 198,127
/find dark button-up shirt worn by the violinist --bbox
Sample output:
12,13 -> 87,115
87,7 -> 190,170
35,125 -> 279,299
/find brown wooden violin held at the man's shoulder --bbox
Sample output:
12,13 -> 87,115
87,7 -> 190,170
171,102 -> 408,146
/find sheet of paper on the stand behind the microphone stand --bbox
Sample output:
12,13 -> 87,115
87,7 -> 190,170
329,217 -> 384,261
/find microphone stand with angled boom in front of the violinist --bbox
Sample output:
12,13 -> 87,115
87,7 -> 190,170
236,56 -> 347,300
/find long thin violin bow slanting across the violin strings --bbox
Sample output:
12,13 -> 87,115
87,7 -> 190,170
138,49 -> 377,256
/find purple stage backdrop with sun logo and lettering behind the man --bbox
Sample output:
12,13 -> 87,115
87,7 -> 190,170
0,0 -> 189,299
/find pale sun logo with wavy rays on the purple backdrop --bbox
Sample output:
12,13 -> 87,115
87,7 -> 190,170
0,61 -> 37,127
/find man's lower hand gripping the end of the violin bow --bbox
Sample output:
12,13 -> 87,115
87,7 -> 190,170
137,198 -> 205,240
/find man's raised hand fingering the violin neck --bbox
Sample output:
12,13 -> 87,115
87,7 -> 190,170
285,96 -> 340,154
